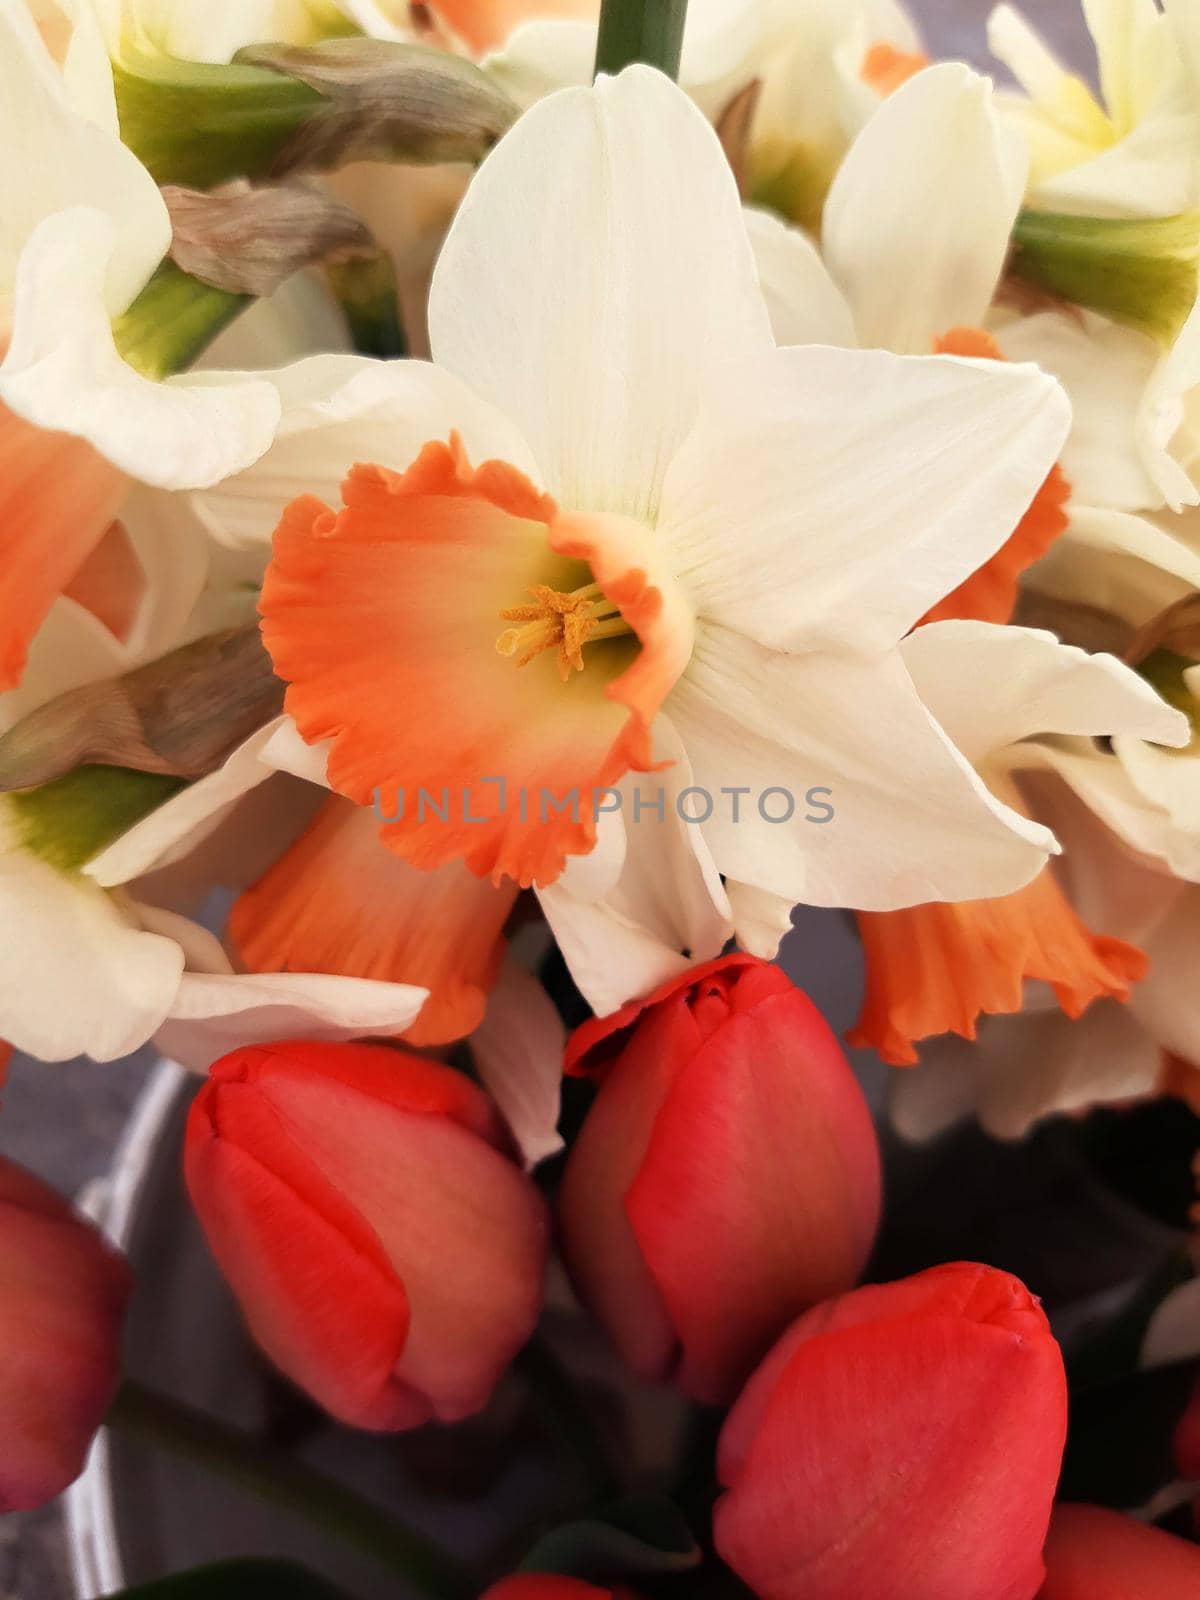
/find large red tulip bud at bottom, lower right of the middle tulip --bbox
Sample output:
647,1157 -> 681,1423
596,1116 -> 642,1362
714,1264 -> 1067,1600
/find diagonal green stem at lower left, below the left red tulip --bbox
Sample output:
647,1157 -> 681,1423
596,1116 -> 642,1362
106,1378 -> 480,1600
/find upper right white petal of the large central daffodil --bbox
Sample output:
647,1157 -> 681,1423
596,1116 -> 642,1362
661,347 -> 1070,651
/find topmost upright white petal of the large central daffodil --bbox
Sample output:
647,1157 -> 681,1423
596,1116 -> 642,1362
429,67 -> 770,523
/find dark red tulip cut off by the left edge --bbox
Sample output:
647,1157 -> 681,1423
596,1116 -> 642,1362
0,1158 -> 133,1512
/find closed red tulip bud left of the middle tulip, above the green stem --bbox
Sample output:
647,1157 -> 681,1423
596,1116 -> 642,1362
186,1042 -> 547,1430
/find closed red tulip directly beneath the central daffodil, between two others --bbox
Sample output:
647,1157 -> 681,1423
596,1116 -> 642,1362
562,955 -> 880,1403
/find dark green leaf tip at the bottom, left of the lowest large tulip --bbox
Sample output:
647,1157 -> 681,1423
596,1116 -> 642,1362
522,1499 -> 701,1582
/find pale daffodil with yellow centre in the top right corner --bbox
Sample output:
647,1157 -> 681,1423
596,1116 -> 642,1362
987,0 -> 1200,218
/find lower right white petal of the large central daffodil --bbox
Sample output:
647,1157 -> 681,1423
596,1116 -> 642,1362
667,627 -> 1054,910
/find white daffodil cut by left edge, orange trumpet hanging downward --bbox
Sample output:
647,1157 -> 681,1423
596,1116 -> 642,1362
0,0 -> 291,688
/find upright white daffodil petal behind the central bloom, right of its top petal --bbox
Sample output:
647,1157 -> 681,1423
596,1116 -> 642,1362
821,62 -> 1029,355
